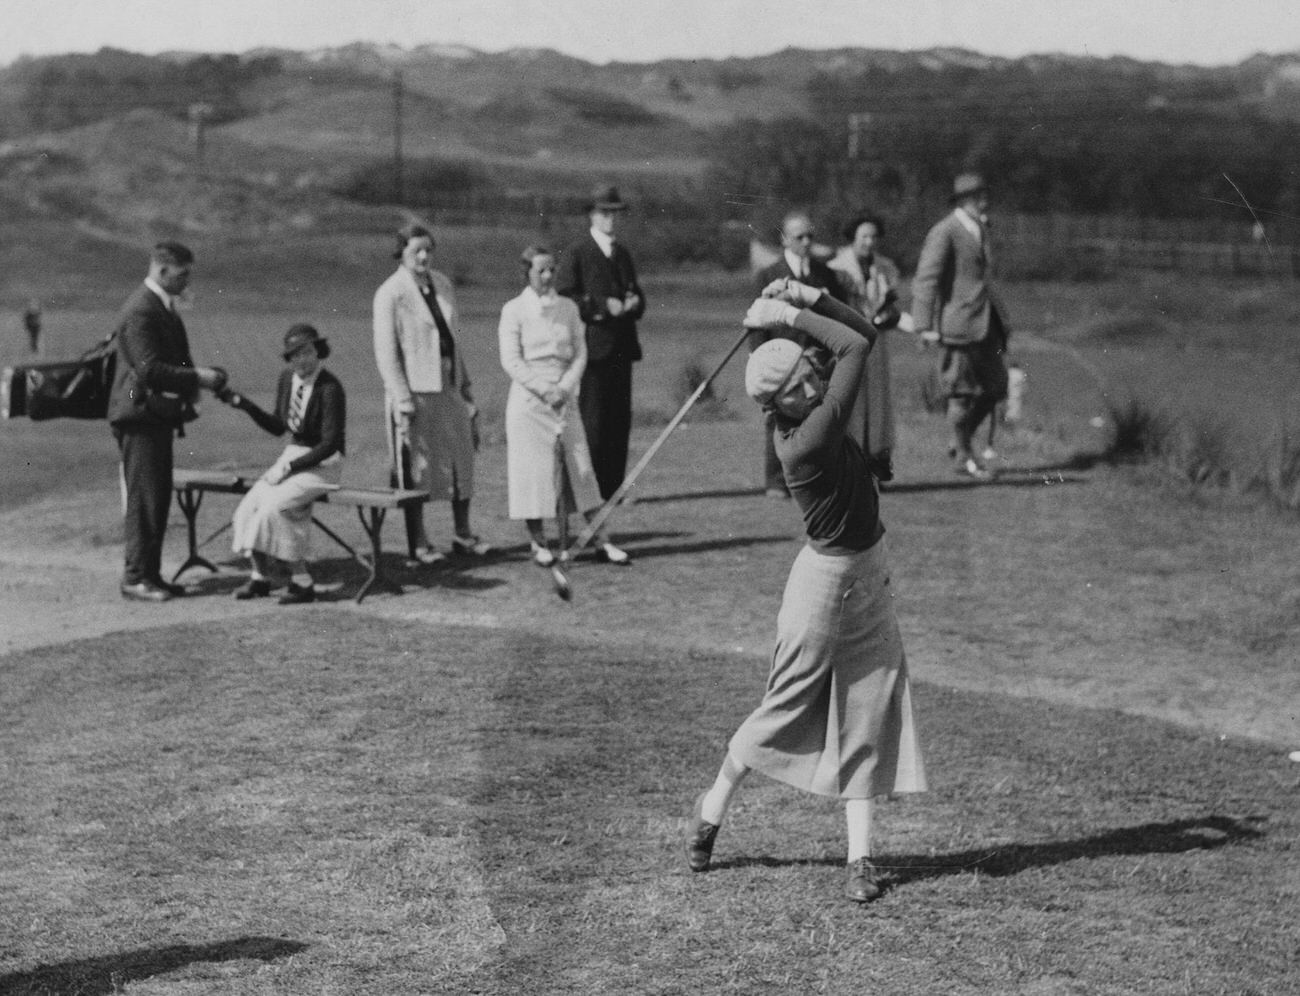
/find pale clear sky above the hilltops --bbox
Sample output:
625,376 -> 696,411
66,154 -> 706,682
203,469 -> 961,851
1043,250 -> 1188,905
0,0 -> 1300,65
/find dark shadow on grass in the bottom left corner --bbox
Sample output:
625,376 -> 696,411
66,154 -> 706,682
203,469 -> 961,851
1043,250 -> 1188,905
0,937 -> 307,996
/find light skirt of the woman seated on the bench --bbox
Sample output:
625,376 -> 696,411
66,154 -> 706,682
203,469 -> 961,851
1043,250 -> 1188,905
230,445 -> 343,563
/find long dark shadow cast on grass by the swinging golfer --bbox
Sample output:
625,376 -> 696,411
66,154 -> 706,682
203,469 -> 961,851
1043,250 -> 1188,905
712,815 -> 1264,885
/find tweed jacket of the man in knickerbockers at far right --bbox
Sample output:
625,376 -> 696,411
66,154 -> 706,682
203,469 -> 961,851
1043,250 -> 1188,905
911,213 -> 1011,346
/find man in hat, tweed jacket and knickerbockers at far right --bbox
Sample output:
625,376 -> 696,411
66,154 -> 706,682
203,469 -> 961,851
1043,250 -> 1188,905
911,173 -> 1010,480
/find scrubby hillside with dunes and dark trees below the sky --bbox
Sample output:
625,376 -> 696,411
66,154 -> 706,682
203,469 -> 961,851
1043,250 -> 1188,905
0,43 -> 1300,242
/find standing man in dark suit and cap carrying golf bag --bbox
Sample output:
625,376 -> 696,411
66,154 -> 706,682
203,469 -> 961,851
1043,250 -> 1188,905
108,242 -> 226,602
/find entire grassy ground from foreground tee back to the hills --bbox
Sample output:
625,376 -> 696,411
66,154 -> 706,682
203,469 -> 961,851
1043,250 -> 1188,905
0,231 -> 1300,996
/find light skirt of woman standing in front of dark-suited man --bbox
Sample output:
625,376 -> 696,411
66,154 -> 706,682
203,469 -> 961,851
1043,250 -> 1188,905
506,384 -> 601,519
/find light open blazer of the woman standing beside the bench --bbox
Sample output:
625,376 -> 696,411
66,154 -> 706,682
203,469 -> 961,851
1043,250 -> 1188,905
373,267 -> 473,408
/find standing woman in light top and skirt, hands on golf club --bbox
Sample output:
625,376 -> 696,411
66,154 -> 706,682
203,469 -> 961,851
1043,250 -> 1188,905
497,246 -> 631,567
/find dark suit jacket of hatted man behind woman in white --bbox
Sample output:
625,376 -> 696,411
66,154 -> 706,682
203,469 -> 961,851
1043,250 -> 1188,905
555,234 -> 646,364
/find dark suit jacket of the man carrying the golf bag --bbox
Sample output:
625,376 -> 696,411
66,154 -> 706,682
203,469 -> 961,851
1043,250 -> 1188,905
108,283 -> 199,428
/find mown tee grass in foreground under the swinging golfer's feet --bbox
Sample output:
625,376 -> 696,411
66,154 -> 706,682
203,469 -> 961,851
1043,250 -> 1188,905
0,610 -> 1300,993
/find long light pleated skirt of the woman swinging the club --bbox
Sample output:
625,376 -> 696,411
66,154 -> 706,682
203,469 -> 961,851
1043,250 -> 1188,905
729,540 -> 926,798
